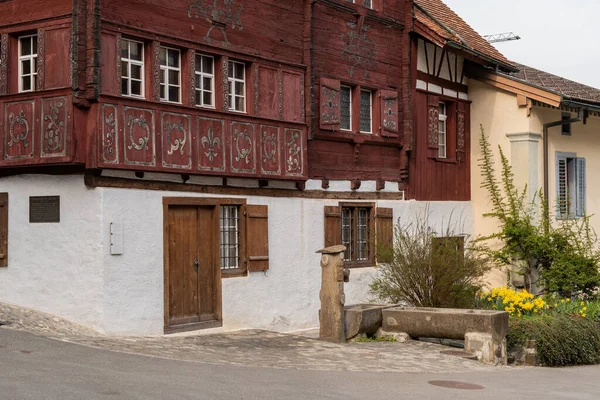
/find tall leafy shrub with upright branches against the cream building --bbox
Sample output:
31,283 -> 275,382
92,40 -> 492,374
478,128 -> 600,297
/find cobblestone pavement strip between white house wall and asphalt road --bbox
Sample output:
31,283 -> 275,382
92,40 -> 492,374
0,303 -> 501,373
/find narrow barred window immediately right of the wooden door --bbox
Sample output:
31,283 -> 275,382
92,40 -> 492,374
220,206 -> 240,270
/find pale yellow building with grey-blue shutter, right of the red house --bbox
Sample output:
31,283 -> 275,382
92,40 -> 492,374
469,64 -> 600,286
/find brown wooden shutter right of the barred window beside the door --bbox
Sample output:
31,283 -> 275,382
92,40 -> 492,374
244,204 -> 269,272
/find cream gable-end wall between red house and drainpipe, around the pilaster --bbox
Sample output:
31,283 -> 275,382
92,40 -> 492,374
469,79 -> 530,287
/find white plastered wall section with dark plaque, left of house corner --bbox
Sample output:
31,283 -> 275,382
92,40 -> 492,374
0,175 -> 103,330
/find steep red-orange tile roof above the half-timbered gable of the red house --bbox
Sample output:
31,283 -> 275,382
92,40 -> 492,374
414,0 -> 512,66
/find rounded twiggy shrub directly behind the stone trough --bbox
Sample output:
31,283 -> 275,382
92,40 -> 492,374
371,212 -> 491,308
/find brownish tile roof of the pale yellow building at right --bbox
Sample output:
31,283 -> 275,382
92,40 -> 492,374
508,62 -> 600,103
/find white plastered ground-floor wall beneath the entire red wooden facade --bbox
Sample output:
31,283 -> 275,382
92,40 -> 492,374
0,176 -> 473,335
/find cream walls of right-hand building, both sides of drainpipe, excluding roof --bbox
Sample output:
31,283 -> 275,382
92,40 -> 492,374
469,79 -> 600,287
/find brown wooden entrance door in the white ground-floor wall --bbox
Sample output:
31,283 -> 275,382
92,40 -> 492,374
165,205 -> 221,330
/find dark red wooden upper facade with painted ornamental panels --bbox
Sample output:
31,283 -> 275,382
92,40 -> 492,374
0,0 -> 478,200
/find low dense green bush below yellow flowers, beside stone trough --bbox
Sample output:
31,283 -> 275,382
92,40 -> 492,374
506,316 -> 600,367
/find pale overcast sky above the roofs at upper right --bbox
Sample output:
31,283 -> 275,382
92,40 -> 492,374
443,0 -> 600,89
